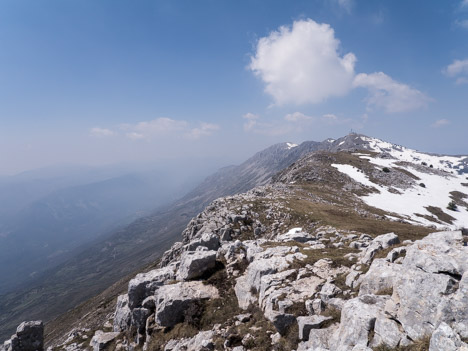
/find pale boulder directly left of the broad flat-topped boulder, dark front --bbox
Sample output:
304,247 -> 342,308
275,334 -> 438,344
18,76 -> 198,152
128,266 -> 175,310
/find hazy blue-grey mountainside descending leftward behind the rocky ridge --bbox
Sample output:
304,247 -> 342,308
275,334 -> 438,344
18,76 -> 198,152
0,134 -> 402,338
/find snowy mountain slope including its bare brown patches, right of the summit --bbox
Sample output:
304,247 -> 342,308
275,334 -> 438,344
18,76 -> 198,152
333,136 -> 468,229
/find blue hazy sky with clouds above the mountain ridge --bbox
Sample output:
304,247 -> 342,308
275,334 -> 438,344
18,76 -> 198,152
0,0 -> 468,175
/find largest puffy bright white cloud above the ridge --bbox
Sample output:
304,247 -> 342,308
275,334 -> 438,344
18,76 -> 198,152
249,19 -> 356,105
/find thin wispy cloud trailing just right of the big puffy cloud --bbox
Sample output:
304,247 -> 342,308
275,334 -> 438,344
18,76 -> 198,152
354,72 -> 430,113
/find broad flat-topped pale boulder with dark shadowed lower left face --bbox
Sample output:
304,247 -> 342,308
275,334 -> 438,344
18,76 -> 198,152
155,281 -> 219,327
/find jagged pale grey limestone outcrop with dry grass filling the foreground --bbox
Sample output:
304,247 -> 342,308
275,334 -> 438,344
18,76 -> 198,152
2,183 -> 468,351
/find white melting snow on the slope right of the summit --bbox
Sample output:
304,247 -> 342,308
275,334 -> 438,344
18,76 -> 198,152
332,146 -> 468,229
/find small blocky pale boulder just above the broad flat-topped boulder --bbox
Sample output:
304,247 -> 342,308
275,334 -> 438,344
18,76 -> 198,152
177,250 -> 216,280
